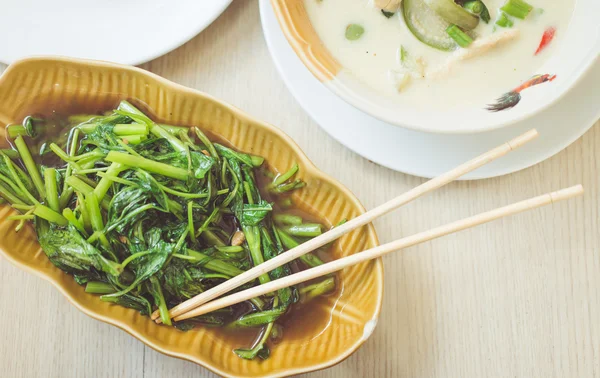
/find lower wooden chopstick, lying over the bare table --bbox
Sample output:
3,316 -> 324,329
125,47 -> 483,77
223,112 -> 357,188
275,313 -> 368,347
174,185 -> 583,321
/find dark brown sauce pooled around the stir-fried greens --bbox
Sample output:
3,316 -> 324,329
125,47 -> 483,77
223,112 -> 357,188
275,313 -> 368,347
0,99 -> 343,353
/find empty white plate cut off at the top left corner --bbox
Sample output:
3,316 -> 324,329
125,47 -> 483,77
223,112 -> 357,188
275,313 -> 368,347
0,0 -> 232,65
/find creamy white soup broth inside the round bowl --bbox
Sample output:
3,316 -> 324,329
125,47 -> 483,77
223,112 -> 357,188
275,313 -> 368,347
304,0 -> 575,109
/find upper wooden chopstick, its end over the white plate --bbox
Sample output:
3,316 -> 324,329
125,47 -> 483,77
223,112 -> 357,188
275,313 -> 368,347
151,129 -> 539,323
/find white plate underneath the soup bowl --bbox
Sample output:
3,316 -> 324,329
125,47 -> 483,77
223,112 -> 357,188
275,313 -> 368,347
260,0 -> 600,179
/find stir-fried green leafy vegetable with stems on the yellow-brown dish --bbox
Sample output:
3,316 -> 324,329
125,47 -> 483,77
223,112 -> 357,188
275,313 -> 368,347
0,101 -> 335,359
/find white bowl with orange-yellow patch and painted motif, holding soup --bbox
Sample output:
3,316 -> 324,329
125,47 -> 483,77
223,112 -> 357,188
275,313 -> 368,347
271,0 -> 600,134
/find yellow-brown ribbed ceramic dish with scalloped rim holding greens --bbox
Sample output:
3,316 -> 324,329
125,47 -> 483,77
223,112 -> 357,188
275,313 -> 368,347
0,58 -> 383,377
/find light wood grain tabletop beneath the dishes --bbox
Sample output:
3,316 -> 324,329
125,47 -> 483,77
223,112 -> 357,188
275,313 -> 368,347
0,0 -> 600,378
